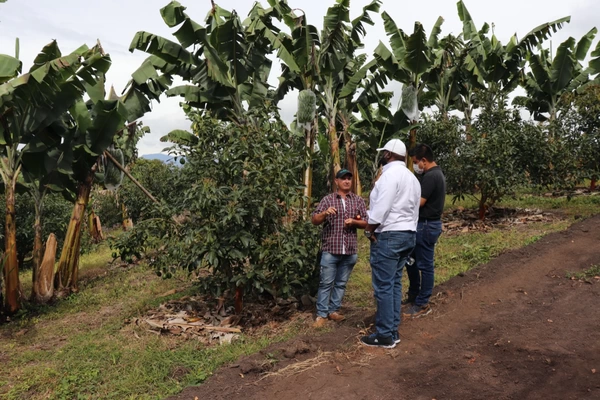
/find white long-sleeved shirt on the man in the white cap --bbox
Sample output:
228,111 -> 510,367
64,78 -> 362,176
368,161 -> 421,232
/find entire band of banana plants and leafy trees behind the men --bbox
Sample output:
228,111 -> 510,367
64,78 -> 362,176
0,0 -> 600,313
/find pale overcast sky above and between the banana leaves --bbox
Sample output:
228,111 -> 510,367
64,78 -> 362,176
0,0 -> 600,155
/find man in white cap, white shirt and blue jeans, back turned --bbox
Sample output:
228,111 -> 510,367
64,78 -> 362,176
360,139 -> 421,348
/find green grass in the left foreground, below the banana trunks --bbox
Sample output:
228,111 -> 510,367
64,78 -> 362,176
0,241 -> 302,399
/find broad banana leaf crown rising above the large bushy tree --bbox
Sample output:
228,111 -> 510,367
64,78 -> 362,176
130,1 -> 272,125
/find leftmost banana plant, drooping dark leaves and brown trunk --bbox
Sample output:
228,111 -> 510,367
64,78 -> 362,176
0,41 -> 110,313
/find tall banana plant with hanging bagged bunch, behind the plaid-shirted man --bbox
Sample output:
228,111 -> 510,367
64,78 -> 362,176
271,0 -> 381,196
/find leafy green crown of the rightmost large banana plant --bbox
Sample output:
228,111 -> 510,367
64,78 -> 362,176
513,28 -> 598,121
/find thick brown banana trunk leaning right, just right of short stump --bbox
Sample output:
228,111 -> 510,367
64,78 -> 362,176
54,172 -> 94,294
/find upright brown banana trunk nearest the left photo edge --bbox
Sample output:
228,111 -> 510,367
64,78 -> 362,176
3,177 -> 21,314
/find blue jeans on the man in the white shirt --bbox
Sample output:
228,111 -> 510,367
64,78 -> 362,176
371,231 -> 416,338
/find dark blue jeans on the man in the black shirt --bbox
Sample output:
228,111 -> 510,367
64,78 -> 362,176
406,221 -> 442,306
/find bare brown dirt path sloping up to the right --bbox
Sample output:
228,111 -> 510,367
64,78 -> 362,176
174,216 -> 600,400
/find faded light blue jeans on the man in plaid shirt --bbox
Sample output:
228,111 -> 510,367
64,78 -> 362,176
317,251 -> 357,318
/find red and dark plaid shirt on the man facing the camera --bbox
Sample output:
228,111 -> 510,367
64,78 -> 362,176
313,193 -> 367,254
